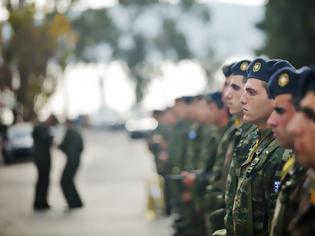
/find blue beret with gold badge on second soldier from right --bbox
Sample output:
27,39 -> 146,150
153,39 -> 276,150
268,67 -> 300,98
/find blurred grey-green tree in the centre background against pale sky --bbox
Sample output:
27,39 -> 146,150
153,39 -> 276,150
73,0 -> 212,103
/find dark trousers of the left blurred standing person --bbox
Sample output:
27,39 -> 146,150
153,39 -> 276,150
34,157 -> 50,208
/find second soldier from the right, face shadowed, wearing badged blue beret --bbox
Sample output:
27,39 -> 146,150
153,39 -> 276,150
268,65 -> 306,236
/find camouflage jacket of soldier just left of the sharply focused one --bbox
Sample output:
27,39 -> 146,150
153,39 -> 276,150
225,123 -> 257,235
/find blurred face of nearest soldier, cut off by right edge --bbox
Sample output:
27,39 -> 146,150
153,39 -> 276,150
287,92 -> 315,168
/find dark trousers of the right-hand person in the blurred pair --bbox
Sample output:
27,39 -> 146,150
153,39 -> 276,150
61,158 -> 83,208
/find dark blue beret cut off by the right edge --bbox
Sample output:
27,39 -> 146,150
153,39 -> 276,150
298,66 -> 315,99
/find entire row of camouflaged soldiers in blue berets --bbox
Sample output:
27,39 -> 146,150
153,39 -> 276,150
148,58 -> 315,236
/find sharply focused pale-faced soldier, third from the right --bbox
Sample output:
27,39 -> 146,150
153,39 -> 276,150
232,58 -> 292,236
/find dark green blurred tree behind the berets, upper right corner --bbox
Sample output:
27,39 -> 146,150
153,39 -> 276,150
257,0 -> 315,67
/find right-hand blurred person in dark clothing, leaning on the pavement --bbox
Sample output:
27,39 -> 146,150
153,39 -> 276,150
59,120 -> 83,209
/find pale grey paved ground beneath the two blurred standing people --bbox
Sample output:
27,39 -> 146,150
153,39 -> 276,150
0,131 -> 172,236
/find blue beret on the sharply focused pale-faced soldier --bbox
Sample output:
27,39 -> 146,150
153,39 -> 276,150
247,58 -> 294,83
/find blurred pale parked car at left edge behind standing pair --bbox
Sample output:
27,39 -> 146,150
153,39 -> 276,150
2,122 -> 33,164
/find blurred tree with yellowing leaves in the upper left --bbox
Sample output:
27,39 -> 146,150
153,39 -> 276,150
0,0 -> 75,118
